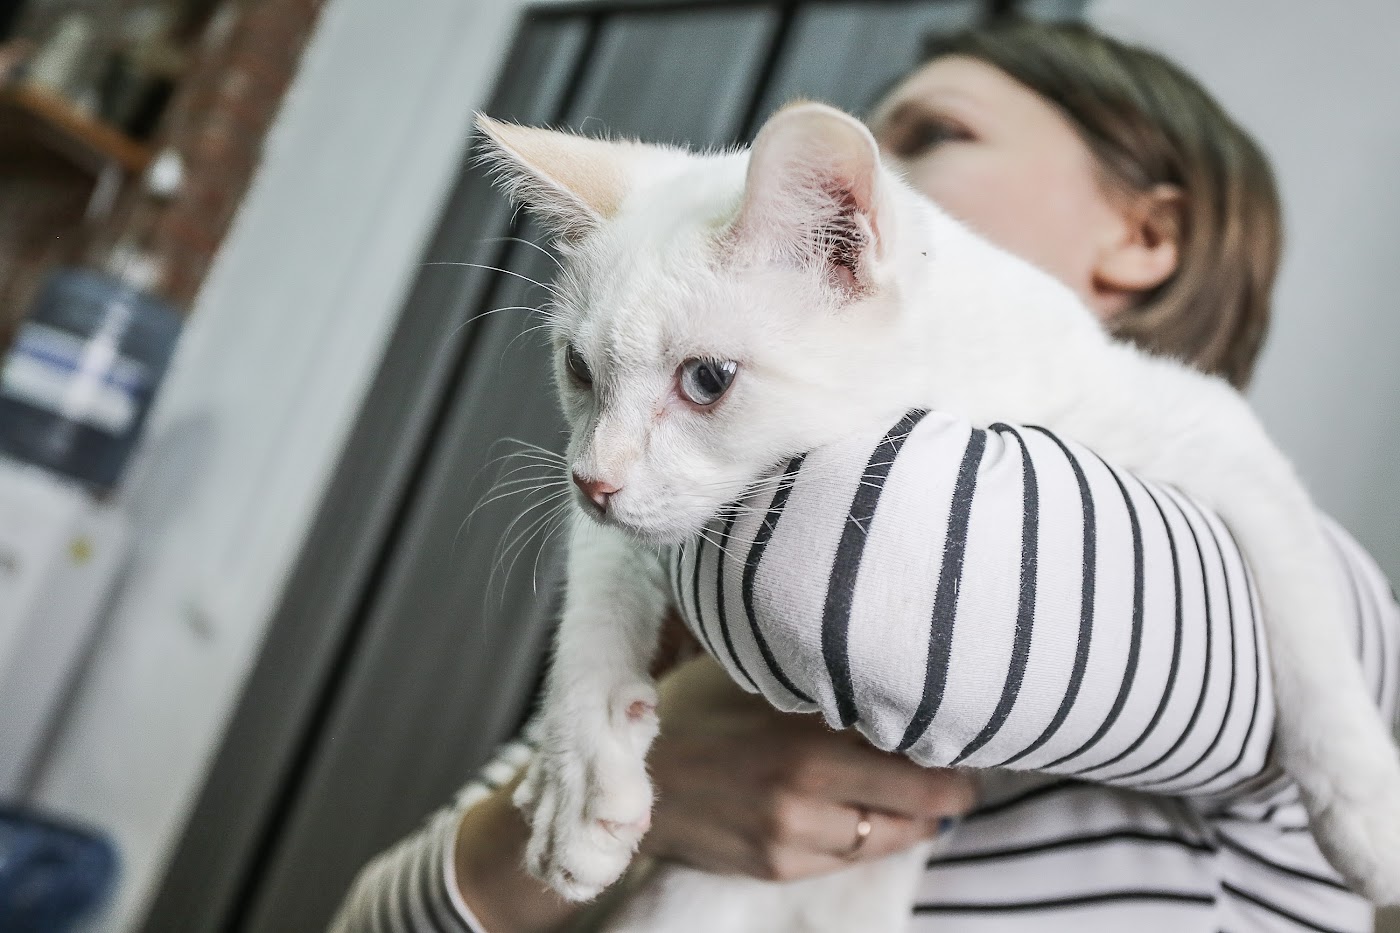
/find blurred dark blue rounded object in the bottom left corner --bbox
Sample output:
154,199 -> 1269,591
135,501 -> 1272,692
0,807 -> 118,933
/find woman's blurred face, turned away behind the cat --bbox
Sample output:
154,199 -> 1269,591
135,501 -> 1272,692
871,56 -> 1176,319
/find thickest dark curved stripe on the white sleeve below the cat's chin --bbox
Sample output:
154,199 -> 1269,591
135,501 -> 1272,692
822,412 -> 928,727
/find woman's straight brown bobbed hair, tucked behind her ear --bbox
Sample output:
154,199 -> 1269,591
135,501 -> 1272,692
924,20 -> 1282,388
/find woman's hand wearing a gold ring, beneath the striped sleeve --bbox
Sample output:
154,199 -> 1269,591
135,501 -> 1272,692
641,633 -> 977,880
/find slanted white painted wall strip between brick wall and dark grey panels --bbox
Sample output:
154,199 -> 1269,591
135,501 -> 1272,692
34,0 -> 534,930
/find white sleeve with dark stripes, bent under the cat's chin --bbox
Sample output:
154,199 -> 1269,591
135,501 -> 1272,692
671,412 -> 1396,799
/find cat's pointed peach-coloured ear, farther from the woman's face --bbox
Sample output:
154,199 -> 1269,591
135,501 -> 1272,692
476,113 -> 645,240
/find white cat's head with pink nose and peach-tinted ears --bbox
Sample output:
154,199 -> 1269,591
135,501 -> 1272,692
479,104 -> 917,545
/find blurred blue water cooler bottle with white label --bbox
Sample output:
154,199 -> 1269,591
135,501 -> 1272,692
0,263 -> 181,490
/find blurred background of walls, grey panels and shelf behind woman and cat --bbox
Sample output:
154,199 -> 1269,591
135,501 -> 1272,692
0,0 -> 1400,933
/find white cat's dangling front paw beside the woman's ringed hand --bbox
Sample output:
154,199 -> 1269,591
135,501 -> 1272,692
514,694 -> 651,901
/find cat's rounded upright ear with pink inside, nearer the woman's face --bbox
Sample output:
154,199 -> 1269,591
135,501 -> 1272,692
735,102 -> 886,291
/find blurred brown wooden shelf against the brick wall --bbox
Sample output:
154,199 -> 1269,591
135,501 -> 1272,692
0,84 -> 151,175
